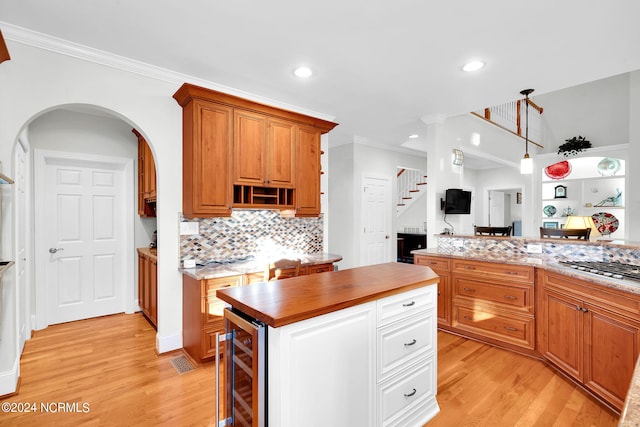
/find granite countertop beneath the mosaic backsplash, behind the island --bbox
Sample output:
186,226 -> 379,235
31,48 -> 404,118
178,252 -> 342,280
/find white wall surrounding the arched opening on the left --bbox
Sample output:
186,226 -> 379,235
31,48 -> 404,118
0,41 -> 182,392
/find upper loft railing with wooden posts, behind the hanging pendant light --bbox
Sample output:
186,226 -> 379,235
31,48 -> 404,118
471,99 -> 544,148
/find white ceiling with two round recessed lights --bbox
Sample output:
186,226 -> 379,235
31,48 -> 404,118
0,0 -> 640,152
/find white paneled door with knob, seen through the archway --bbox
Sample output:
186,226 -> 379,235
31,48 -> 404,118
36,153 -> 132,324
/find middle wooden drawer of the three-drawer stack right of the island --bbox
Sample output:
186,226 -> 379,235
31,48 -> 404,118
453,275 -> 534,314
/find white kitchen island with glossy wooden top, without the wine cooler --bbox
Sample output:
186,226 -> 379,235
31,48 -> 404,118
216,263 -> 439,427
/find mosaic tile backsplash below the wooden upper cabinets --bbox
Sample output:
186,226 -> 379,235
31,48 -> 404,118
180,209 -> 323,265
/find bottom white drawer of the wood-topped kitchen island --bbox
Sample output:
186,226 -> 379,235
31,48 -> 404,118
377,355 -> 437,426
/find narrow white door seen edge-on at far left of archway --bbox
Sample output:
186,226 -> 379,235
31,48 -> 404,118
14,141 -> 31,354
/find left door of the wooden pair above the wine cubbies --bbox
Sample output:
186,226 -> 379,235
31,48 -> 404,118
233,110 -> 267,185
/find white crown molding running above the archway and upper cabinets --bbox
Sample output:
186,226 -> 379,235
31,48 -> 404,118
0,21 -> 335,121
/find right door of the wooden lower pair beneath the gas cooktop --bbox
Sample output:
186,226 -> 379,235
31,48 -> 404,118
584,306 -> 640,409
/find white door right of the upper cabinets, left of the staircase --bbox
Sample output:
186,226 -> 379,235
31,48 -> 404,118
360,176 -> 392,265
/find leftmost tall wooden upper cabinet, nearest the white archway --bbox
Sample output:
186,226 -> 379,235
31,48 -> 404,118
182,100 -> 233,218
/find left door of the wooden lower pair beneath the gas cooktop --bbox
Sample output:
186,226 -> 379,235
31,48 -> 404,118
542,291 -> 584,381
